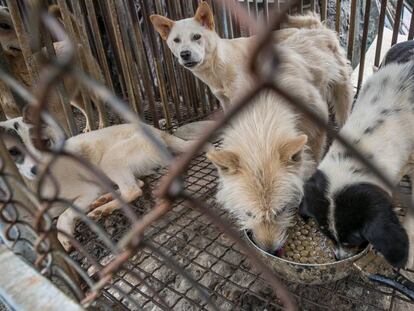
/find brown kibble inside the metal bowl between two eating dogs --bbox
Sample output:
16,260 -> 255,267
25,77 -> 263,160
277,216 -> 336,264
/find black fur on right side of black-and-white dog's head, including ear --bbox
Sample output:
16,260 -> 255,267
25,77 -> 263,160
334,183 -> 409,267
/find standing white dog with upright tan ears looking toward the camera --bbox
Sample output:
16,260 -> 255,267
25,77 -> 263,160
151,1 -> 352,126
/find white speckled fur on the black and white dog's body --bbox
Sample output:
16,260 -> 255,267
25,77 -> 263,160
319,63 -> 414,267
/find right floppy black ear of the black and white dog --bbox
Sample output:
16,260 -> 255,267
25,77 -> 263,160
363,206 -> 409,268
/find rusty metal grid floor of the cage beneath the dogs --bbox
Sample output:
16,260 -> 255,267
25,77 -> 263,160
72,147 -> 414,310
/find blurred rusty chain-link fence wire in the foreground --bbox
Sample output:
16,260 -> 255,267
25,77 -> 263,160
0,0 -> 412,310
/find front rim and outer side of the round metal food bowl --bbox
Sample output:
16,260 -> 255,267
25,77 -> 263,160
244,230 -> 370,285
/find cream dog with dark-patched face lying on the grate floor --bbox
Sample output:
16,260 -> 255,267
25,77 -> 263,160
0,117 -> 196,250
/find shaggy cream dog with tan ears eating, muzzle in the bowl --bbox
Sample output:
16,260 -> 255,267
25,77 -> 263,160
204,22 -> 352,252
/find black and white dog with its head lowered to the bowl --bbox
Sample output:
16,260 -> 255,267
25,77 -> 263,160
300,41 -> 414,267
